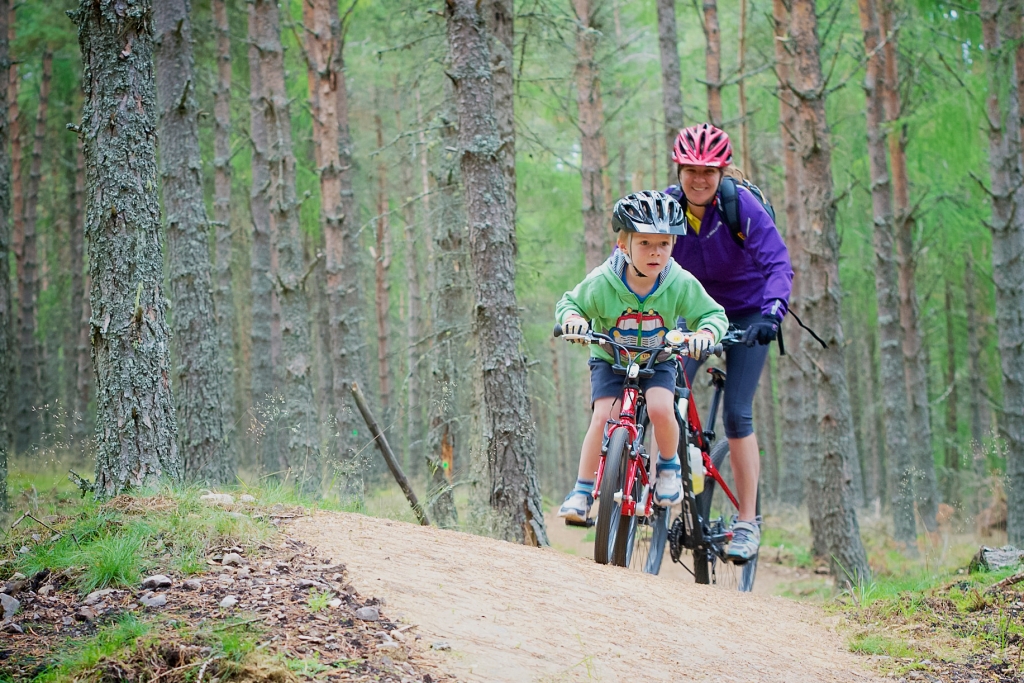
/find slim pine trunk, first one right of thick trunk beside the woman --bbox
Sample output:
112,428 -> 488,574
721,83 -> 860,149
857,0 -> 918,552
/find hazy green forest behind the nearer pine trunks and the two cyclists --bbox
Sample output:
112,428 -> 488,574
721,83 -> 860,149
0,0 -> 1011,585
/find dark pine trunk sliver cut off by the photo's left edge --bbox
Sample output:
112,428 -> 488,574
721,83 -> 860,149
0,0 -> 14,511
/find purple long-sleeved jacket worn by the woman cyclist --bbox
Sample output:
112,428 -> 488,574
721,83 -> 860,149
665,185 -> 793,318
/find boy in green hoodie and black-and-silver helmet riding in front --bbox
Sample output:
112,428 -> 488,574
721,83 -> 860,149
555,191 -> 729,521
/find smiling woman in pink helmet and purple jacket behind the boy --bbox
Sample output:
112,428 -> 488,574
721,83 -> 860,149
666,123 -> 793,563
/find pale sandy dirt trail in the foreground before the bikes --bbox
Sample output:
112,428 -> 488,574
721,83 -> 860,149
293,513 -> 876,683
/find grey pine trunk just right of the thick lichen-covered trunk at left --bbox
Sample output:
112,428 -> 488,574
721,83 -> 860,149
154,0 -> 236,484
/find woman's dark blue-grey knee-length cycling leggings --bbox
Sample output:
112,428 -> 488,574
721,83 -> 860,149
684,313 -> 771,438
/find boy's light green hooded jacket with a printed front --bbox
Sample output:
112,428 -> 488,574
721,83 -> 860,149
555,250 -> 729,362
